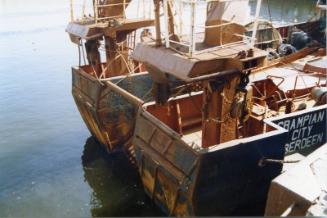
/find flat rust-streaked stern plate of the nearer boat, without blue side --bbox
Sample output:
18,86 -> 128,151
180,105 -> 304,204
133,109 -> 198,216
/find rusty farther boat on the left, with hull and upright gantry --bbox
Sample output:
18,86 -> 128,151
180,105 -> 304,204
66,0 -> 154,152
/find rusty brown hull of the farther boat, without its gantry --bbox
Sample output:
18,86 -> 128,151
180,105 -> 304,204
72,67 -> 152,151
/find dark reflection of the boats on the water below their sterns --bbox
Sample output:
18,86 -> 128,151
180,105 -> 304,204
82,137 -> 163,217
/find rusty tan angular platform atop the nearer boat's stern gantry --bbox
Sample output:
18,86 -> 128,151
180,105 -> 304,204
131,42 -> 267,81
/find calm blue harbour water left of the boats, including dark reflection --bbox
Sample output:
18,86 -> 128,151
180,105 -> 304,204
0,0 -> 320,217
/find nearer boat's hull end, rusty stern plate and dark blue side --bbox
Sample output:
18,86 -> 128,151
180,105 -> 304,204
133,108 -> 286,216
